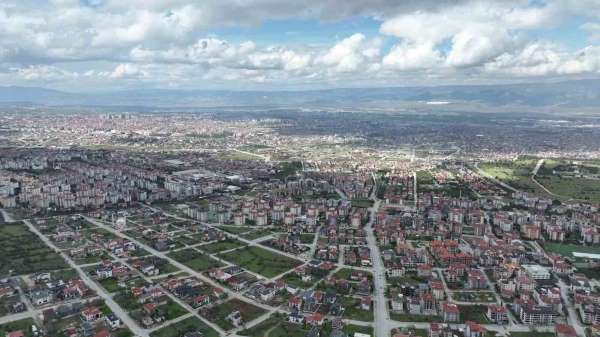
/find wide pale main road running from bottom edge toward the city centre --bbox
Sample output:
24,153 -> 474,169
365,176 -> 391,337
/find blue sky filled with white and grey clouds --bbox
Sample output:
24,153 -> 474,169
0,0 -> 600,92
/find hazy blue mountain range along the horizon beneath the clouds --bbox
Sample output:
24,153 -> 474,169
0,79 -> 600,108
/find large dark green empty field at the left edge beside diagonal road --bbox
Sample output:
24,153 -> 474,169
0,223 -> 67,277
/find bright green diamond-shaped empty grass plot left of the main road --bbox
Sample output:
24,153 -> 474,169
219,246 -> 302,278
